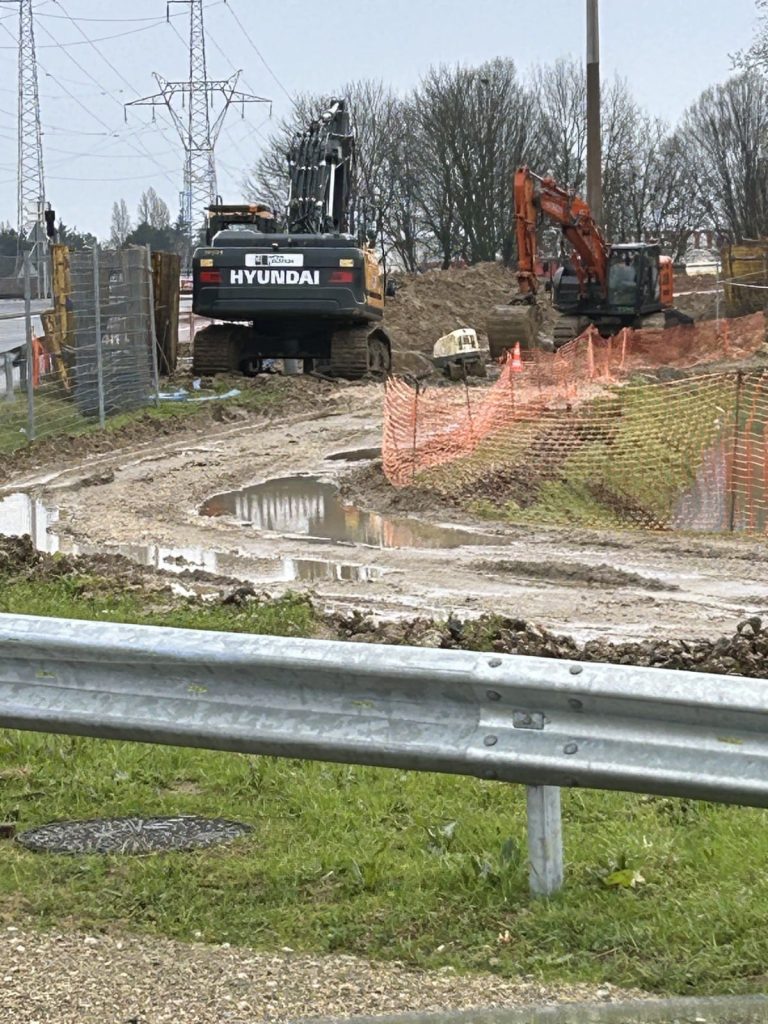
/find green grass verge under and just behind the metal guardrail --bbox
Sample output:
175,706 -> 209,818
0,572 -> 768,993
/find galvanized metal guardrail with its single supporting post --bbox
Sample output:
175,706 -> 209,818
0,615 -> 768,892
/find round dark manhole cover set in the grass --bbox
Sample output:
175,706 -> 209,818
16,815 -> 251,854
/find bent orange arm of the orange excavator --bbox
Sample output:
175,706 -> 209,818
514,167 -> 608,296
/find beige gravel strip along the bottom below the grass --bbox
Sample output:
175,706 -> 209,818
0,928 -> 651,1024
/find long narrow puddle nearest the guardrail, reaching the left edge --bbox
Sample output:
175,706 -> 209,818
0,492 -> 385,583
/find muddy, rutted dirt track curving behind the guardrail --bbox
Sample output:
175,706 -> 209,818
0,382 -> 768,641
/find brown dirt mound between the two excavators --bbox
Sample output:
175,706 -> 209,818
386,263 -> 517,355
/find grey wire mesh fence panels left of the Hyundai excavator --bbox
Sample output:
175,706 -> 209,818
0,246 -> 158,452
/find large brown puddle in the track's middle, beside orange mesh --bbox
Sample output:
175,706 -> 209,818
201,476 -> 499,548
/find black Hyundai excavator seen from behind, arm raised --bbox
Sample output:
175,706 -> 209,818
193,99 -> 391,379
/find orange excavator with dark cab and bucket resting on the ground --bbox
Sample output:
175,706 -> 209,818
486,167 -> 693,358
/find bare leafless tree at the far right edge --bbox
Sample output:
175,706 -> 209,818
680,71 -> 768,241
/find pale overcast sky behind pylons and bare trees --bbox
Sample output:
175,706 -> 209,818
0,0 -> 755,237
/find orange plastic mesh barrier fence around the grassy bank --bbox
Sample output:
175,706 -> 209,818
382,313 -> 768,532
